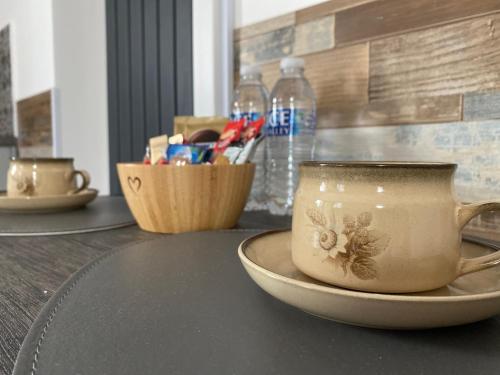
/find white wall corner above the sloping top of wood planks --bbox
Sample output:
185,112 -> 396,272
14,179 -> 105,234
234,0 -> 325,28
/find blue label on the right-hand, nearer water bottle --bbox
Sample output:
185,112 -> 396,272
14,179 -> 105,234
267,108 -> 315,137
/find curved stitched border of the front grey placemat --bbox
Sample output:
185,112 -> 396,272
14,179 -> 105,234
12,228 -> 269,375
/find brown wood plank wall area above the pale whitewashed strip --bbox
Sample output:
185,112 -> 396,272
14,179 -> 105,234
234,0 -> 500,128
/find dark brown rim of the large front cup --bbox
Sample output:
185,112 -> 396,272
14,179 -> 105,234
300,161 -> 457,169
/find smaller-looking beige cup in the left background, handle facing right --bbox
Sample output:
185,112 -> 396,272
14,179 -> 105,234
7,158 -> 90,197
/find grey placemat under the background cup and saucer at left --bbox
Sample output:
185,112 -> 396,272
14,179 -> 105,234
0,197 -> 135,236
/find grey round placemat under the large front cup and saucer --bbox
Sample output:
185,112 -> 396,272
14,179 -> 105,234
14,229 -> 500,375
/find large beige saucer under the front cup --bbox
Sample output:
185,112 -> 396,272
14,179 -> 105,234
238,231 -> 500,329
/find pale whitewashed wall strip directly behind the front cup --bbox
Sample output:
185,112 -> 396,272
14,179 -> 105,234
316,121 -> 500,201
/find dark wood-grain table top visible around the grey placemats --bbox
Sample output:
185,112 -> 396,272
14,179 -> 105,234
0,207 -> 499,375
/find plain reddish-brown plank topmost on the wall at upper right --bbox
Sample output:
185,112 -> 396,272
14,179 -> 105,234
336,0 -> 500,45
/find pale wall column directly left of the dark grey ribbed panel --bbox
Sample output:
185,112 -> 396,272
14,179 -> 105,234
53,0 -> 109,194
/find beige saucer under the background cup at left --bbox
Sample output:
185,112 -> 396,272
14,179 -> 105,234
0,189 -> 98,213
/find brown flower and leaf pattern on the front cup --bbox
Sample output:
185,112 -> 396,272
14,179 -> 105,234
306,208 -> 390,280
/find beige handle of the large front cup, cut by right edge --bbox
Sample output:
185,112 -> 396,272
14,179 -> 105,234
457,201 -> 500,276
